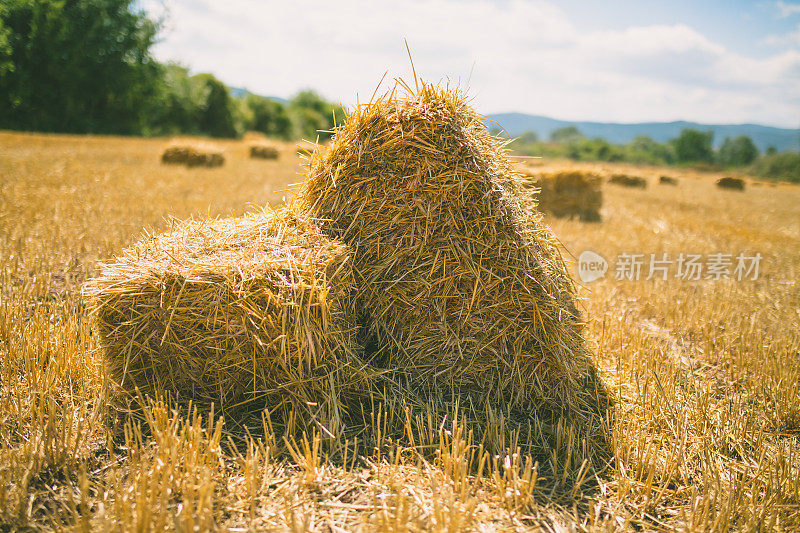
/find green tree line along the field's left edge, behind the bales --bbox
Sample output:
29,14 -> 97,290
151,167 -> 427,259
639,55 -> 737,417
0,0 -> 344,139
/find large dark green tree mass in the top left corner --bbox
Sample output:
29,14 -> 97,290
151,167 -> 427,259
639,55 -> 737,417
0,0 -> 160,133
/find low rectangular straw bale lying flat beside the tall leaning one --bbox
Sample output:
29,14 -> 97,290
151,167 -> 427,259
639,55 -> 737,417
86,206 -> 368,426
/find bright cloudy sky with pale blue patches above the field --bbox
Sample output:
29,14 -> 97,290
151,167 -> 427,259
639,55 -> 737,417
141,0 -> 800,128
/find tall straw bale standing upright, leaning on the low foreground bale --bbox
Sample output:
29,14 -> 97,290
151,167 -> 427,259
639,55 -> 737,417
301,84 -> 593,424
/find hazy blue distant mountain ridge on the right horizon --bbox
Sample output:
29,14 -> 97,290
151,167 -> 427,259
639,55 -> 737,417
487,113 -> 800,152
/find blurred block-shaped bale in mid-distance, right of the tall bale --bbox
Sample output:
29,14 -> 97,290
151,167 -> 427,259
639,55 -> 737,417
523,170 -> 603,222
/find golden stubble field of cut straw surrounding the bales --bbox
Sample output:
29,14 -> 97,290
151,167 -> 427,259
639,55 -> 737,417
0,132 -> 800,531
